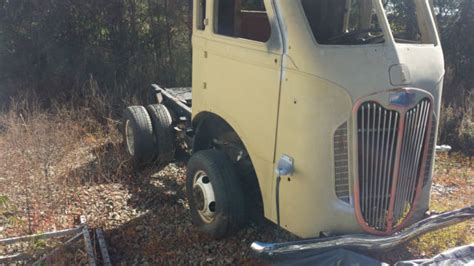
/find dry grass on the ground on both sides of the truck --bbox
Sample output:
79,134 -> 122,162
0,95 -> 474,262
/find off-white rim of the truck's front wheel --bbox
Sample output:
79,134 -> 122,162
193,171 -> 216,223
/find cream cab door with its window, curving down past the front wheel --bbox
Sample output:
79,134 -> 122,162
203,0 -> 282,216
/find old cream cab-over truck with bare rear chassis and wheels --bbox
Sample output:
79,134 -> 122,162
124,0 -> 474,250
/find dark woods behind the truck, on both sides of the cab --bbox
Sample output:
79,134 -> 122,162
0,0 -> 474,153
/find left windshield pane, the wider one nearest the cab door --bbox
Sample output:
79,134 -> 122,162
301,0 -> 385,45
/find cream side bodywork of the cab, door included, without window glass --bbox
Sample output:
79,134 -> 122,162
192,0 -> 282,216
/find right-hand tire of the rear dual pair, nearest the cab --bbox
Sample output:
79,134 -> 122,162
146,104 -> 176,164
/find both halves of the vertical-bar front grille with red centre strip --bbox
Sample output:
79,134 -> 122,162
356,99 -> 431,231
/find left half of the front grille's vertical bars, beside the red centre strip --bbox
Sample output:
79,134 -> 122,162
358,102 -> 400,230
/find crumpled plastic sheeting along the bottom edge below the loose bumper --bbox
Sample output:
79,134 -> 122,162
274,244 -> 474,266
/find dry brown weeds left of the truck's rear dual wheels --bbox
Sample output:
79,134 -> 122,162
0,83 -> 133,235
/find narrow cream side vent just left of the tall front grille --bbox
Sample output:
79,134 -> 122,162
334,122 -> 350,203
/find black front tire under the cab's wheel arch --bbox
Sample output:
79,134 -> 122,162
186,150 -> 246,238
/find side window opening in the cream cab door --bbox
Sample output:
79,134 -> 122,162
216,0 -> 271,42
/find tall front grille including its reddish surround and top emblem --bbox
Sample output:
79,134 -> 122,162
353,88 -> 434,235
